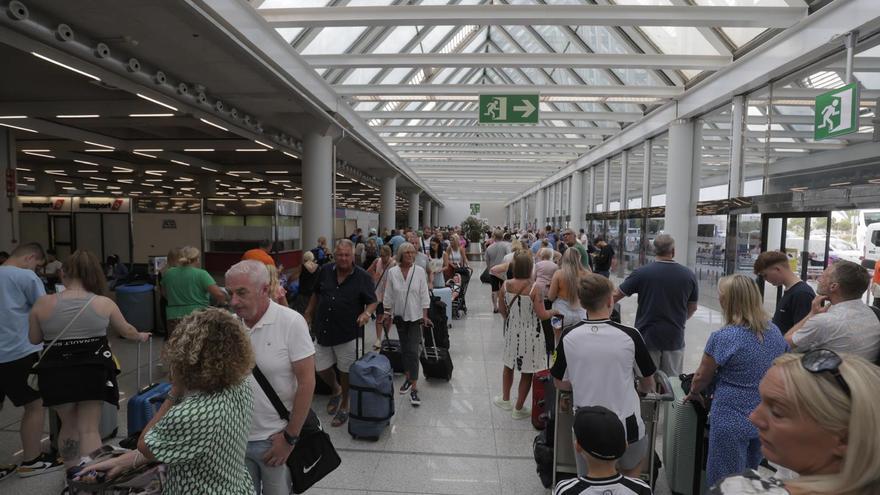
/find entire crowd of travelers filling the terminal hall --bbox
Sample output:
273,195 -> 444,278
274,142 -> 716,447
0,222 -> 880,495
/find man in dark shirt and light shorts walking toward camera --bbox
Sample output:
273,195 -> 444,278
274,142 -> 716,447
303,239 -> 377,426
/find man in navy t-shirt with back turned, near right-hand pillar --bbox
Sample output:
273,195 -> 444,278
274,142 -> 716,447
614,234 -> 699,376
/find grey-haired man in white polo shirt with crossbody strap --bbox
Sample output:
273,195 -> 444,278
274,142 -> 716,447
226,260 -> 317,495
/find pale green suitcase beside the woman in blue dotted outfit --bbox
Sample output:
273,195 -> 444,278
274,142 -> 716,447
663,377 -> 708,495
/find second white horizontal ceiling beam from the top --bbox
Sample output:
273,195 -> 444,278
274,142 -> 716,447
303,53 -> 733,70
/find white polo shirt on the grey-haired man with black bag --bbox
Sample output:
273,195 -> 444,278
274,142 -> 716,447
248,302 -> 315,442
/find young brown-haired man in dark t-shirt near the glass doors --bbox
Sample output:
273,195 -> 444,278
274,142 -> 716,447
755,251 -> 816,335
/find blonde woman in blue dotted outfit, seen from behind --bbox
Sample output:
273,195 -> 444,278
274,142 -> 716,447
685,274 -> 788,486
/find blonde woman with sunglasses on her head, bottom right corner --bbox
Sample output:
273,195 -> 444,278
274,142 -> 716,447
712,349 -> 880,495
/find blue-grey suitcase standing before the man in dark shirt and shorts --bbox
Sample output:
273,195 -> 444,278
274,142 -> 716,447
348,340 -> 394,441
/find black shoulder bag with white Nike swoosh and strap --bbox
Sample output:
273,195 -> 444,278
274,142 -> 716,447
253,366 -> 342,493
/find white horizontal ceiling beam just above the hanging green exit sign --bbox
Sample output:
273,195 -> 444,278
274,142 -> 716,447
333,84 -> 684,98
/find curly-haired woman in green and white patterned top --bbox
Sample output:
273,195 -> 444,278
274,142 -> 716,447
81,308 -> 254,495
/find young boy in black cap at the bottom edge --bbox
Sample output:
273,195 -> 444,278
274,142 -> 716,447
553,406 -> 652,495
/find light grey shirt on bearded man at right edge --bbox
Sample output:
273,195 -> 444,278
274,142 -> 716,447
792,299 -> 880,362
